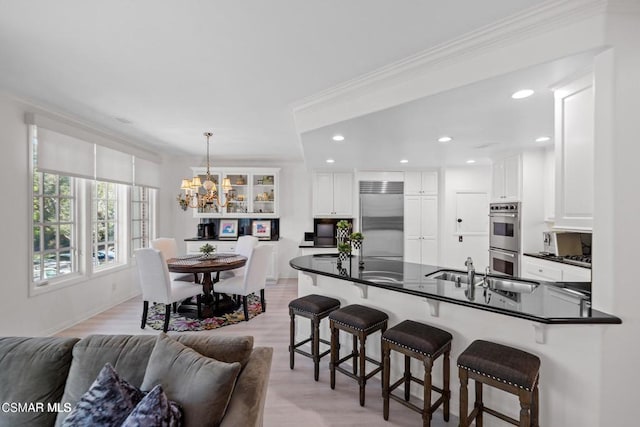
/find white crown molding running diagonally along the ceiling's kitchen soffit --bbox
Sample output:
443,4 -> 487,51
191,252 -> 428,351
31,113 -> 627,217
291,0 -> 608,114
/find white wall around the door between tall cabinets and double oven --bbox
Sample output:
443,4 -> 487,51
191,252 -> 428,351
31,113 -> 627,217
440,165 -> 491,271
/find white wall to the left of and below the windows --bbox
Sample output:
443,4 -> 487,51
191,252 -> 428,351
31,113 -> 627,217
0,94 -> 139,335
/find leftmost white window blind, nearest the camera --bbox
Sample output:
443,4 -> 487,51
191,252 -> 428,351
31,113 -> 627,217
37,128 -> 94,178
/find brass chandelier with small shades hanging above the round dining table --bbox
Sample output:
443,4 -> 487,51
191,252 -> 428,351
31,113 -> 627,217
178,132 -> 231,211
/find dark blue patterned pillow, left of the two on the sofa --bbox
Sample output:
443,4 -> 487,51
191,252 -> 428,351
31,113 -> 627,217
62,363 -> 143,427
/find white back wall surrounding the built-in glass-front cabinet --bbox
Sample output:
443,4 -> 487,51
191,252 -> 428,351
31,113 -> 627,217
158,157 -> 313,278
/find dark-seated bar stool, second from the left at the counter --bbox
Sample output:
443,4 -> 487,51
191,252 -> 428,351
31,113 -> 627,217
329,304 -> 389,406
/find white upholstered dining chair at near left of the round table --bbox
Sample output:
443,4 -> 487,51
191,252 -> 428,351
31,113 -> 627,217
135,248 -> 202,332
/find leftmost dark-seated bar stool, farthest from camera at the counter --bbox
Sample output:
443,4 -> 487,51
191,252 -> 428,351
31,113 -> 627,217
289,294 -> 340,381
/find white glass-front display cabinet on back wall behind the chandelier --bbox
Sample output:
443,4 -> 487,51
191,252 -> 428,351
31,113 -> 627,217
191,167 -> 280,218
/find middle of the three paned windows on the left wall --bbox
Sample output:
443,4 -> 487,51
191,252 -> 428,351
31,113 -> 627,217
91,181 -> 120,269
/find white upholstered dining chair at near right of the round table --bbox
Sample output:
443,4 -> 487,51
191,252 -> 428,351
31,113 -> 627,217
215,246 -> 273,321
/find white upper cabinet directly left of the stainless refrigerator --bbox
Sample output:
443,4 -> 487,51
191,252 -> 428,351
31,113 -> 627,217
313,172 -> 354,217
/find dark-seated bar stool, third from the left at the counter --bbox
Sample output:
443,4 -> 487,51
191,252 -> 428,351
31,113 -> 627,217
382,320 -> 453,427
